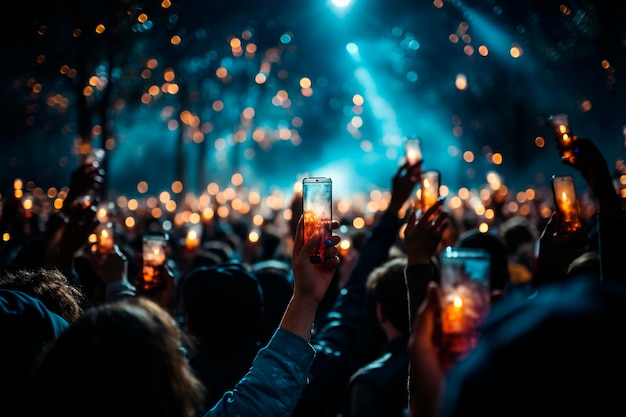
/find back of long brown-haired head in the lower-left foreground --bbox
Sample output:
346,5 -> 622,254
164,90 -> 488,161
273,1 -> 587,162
25,297 -> 201,417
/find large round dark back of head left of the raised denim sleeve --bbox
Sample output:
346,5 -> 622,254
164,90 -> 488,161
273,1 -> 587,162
179,262 -> 263,351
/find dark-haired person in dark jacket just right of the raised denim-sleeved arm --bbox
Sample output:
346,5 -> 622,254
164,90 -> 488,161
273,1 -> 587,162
341,256 -> 410,417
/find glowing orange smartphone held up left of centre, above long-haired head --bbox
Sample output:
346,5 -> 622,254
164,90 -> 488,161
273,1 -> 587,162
140,232 -> 169,290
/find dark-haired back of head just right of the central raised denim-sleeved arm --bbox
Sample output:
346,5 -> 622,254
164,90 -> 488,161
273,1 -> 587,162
367,257 -> 409,333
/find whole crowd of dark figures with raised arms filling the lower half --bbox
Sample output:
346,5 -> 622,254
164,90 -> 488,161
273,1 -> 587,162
0,134 -> 626,417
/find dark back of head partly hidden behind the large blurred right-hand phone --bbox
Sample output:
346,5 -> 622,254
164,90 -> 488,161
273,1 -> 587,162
455,229 -> 509,291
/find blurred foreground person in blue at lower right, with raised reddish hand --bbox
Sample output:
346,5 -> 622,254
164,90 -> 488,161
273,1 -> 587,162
410,247 -> 626,416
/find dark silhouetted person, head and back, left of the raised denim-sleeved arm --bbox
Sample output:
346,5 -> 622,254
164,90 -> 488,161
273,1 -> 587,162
179,262 -> 264,408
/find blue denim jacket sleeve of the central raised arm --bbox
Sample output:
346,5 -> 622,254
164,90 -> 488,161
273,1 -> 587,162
204,329 -> 315,417
